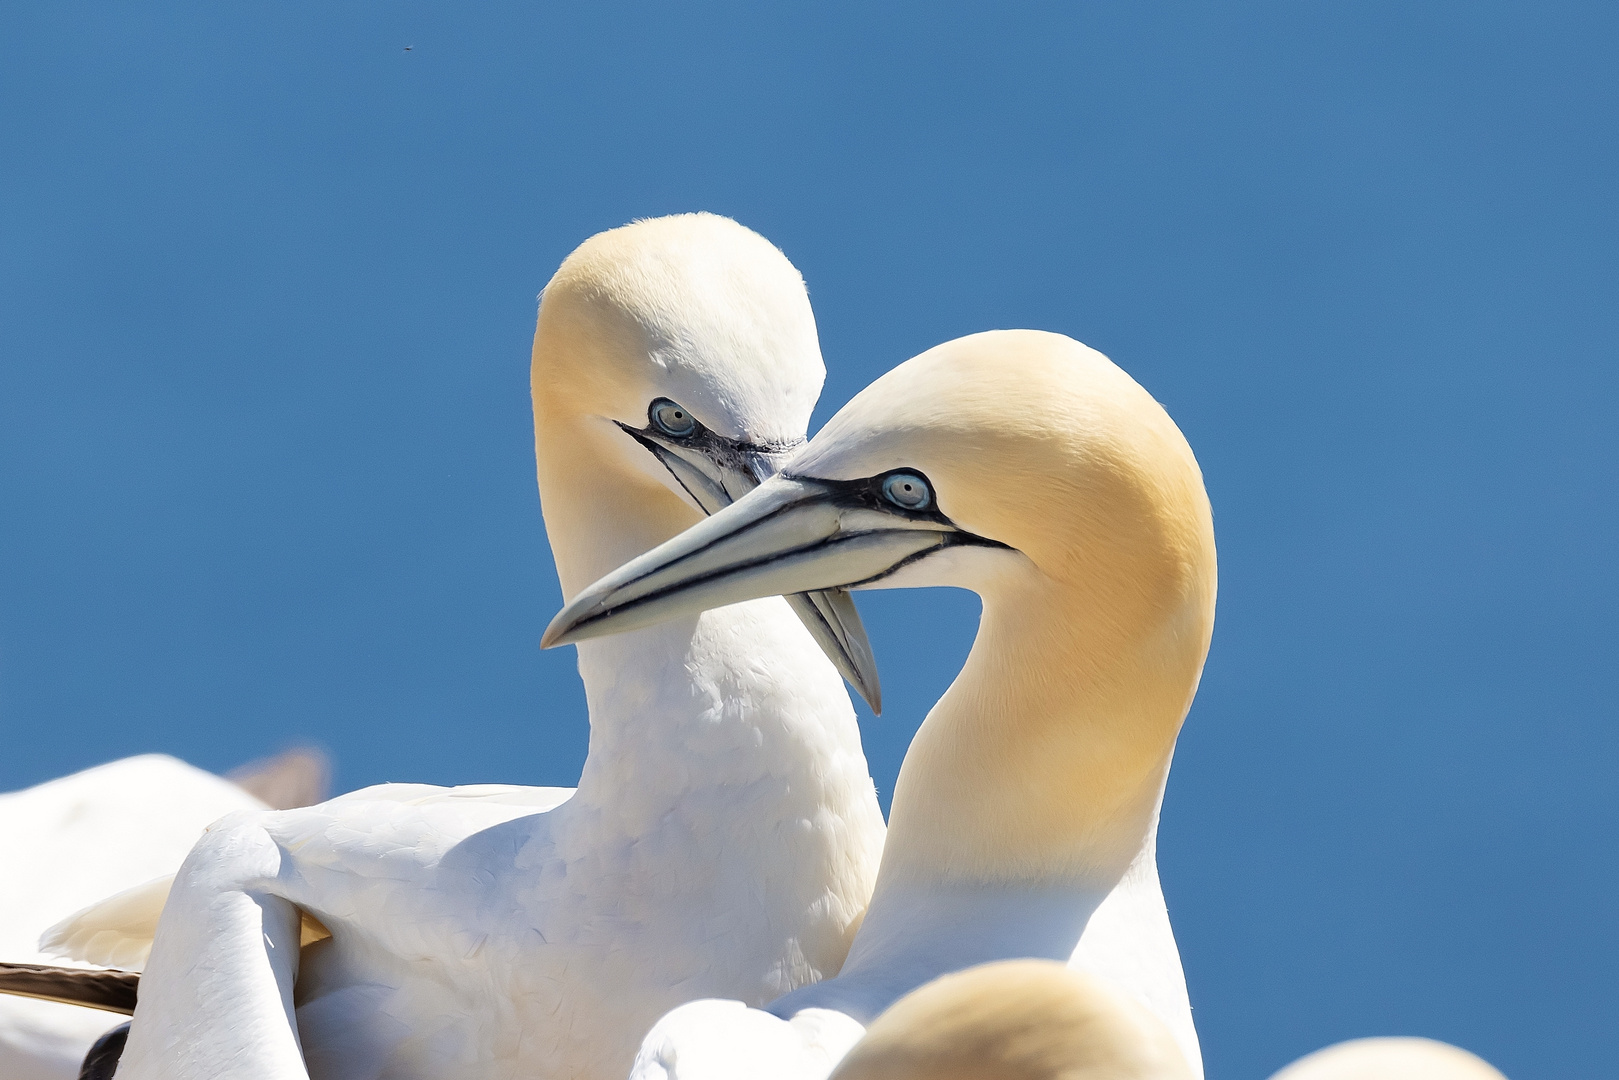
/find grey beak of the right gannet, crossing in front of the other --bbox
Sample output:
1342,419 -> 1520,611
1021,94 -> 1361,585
541,476 -> 999,693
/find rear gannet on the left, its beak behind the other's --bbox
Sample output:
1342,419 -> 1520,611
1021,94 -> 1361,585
44,215 -> 884,1080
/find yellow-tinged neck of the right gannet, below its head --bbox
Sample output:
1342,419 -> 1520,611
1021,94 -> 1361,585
879,572 -> 1213,895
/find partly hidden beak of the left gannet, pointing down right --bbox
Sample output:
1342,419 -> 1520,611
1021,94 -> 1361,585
611,421 -> 882,716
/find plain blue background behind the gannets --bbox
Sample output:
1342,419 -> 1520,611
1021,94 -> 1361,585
0,0 -> 1619,1080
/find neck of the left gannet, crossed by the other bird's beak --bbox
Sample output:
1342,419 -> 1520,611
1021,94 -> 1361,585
536,411 -> 871,839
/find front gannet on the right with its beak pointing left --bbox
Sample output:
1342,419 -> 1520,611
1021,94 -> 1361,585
544,330 -> 1216,1080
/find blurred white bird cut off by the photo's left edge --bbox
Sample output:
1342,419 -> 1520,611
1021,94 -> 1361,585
0,751 -> 324,1080
